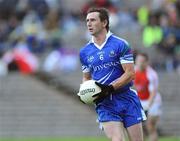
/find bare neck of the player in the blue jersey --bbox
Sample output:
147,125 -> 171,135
93,30 -> 107,46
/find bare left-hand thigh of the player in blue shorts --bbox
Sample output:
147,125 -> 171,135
101,121 -> 124,140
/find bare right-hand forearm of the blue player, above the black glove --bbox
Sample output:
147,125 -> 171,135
112,71 -> 135,90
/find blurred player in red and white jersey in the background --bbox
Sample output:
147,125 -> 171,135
134,53 -> 162,141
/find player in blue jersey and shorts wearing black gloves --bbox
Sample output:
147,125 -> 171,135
80,8 -> 145,141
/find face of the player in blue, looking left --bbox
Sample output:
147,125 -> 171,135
86,12 -> 106,36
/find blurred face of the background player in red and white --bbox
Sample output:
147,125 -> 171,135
135,55 -> 148,70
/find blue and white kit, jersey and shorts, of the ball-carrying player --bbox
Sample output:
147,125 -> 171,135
80,32 -> 146,127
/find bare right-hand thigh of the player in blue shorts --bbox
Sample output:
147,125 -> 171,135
127,123 -> 143,141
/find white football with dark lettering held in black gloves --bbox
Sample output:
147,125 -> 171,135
78,80 -> 101,104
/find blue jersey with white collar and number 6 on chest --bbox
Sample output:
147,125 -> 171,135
80,33 -> 133,89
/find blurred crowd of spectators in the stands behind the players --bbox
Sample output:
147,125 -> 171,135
0,0 -> 180,75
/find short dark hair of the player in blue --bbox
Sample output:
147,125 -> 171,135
87,7 -> 109,31
